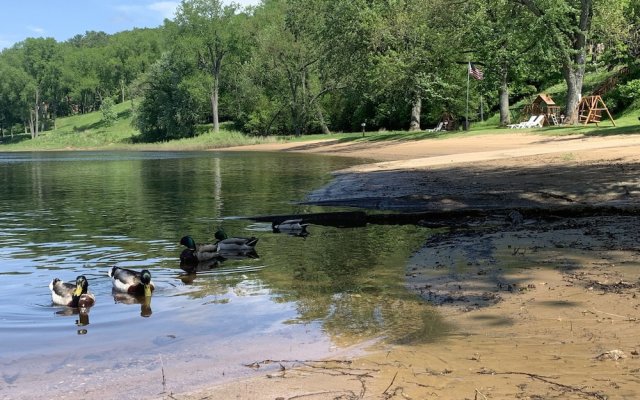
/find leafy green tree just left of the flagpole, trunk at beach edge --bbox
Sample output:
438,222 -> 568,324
312,0 -> 465,130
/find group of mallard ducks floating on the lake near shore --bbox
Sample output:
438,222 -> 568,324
49,219 -> 309,310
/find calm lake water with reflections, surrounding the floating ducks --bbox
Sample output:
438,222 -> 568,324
0,152 -> 446,399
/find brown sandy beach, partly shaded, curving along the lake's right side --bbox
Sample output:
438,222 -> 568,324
178,132 -> 640,400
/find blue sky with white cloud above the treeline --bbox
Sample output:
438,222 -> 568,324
0,0 -> 260,50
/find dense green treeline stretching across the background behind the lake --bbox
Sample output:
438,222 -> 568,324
0,0 -> 640,140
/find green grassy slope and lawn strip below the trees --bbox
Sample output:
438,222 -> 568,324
0,87 -> 640,151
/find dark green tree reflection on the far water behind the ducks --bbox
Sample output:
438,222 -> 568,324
0,152 -> 348,263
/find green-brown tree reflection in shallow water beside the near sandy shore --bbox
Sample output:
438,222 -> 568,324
265,227 -> 447,343
